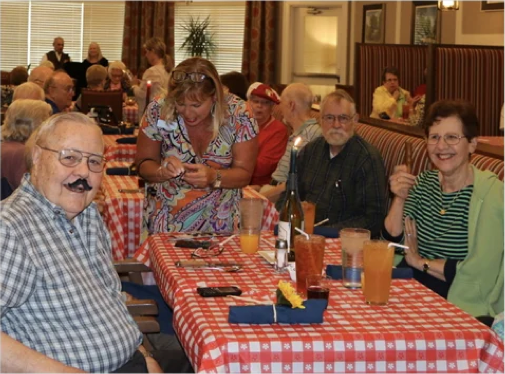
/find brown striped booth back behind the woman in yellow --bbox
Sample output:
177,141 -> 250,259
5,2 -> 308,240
354,43 -> 428,117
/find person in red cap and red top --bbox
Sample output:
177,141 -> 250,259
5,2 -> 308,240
247,82 -> 288,190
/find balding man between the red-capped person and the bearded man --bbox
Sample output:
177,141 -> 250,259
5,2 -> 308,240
259,83 -> 321,203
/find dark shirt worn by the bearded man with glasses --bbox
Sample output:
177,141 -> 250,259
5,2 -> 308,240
297,135 -> 388,237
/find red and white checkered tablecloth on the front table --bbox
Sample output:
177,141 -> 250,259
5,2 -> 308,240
133,233 -> 504,373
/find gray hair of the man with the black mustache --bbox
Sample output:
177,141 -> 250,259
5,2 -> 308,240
25,112 -> 101,171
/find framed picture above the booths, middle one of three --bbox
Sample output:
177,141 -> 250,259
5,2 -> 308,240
411,1 -> 440,44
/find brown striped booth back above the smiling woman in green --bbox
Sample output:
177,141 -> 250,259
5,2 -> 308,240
434,46 -> 504,136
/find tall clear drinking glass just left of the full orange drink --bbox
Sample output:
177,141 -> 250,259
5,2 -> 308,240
339,228 -> 370,288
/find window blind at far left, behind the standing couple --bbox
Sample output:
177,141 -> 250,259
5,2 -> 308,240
0,0 -> 125,70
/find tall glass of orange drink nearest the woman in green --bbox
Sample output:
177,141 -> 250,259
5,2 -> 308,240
361,240 -> 395,305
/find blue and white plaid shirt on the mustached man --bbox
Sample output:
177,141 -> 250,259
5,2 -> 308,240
0,175 -> 142,372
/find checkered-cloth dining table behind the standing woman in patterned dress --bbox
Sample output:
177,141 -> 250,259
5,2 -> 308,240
96,161 -> 279,260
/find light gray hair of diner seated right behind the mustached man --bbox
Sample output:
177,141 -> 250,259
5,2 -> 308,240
2,100 -> 53,143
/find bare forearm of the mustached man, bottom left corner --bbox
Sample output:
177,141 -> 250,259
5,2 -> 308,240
0,332 -> 85,373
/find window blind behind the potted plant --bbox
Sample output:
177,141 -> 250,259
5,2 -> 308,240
174,2 -> 246,74
